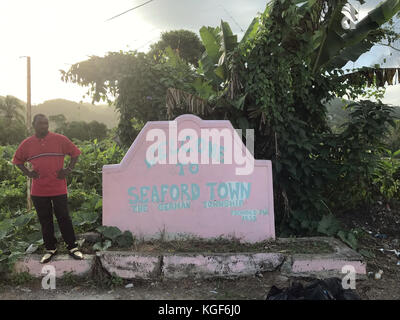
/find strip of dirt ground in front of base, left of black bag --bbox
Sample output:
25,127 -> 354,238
0,274 -> 287,300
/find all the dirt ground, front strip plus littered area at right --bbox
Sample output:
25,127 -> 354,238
0,205 -> 400,300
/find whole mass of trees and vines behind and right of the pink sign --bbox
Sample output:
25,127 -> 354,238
58,0 -> 400,240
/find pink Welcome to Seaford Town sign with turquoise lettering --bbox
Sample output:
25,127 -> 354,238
103,115 -> 275,242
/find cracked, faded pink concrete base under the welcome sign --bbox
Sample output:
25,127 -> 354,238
15,237 -> 367,280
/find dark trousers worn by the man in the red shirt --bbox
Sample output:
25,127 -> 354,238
31,194 -> 76,250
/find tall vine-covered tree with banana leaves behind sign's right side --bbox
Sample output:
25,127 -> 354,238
168,0 -> 400,234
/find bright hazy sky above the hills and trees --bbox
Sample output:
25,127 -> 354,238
0,0 -> 400,105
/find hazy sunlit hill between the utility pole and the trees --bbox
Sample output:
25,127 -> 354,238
32,99 -> 119,129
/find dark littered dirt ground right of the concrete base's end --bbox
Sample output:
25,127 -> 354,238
338,203 -> 400,300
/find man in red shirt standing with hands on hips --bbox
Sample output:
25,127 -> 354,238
13,114 -> 83,263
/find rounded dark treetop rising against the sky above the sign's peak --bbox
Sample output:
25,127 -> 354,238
148,30 -> 204,66
